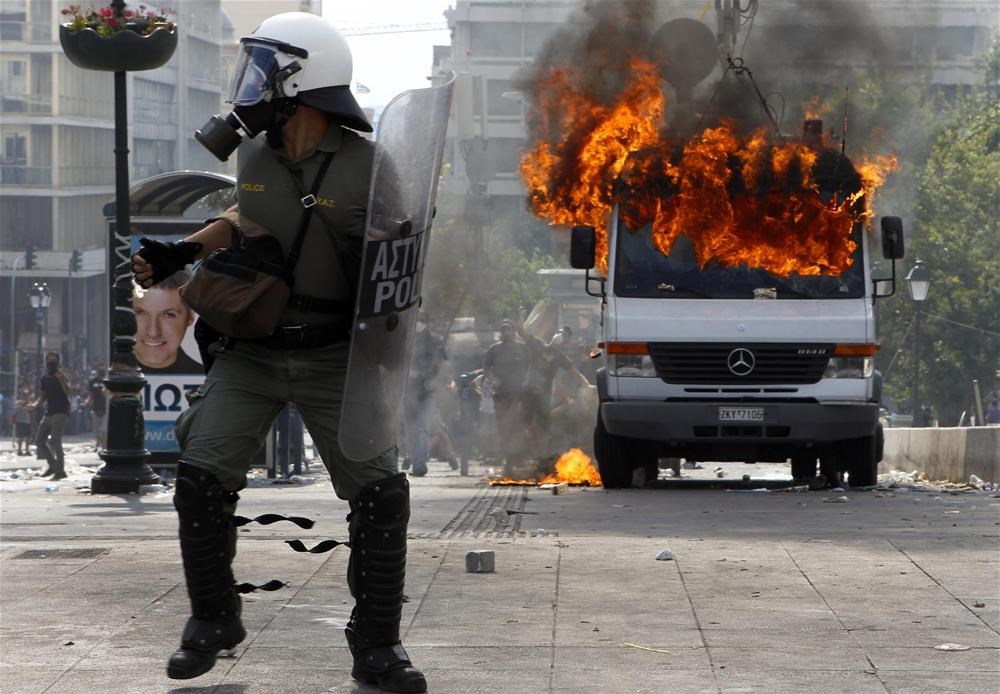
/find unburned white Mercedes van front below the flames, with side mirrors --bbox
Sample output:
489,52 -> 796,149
571,193 -> 903,488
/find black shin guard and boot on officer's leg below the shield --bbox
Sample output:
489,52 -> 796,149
345,473 -> 427,692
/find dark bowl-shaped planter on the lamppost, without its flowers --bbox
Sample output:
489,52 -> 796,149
59,24 -> 177,72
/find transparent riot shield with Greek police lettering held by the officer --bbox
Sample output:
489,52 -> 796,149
339,75 -> 454,460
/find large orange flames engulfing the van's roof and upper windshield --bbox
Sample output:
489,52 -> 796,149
521,58 -> 895,276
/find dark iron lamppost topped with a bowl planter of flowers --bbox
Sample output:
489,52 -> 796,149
59,0 -> 177,494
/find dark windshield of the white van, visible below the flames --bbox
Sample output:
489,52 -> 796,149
614,222 -> 865,299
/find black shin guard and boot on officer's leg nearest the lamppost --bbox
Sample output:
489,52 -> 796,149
167,462 -> 246,680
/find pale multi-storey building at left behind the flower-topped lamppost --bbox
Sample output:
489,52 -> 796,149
0,0 -> 233,384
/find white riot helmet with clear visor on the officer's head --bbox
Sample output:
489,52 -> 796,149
227,12 -> 372,132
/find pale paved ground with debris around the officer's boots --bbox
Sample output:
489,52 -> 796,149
0,442 -> 1000,694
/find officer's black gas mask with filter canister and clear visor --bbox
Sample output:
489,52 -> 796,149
194,37 -> 307,161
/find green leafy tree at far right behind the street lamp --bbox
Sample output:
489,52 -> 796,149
880,40 -> 1000,424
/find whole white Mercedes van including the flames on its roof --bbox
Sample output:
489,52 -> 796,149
571,121 -> 903,487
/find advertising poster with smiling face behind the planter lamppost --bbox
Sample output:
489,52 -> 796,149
132,234 -> 205,455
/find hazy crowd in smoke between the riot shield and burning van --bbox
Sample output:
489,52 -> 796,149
402,310 -> 597,477
